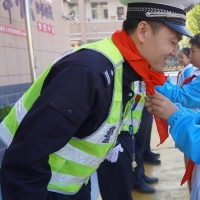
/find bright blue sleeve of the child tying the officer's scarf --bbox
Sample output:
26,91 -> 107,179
168,104 -> 200,164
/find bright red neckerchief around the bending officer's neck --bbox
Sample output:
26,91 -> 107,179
112,29 -> 168,144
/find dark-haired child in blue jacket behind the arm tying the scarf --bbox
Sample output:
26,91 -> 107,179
155,34 -> 200,109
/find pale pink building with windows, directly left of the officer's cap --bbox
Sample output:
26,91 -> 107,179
68,0 -> 126,46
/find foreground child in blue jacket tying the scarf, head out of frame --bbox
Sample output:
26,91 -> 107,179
145,93 -> 200,200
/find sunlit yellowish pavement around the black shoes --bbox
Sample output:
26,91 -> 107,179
92,123 -> 190,200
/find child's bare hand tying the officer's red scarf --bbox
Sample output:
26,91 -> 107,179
145,92 -> 178,120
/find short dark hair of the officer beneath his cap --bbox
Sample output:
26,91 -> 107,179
122,19 -> 164,35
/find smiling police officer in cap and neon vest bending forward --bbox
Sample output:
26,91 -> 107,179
0,0 -> 195,200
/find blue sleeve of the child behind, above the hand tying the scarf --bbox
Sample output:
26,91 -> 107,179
156,76 -> 200,108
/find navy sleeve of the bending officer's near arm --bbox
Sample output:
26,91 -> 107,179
2,66 -> 104,200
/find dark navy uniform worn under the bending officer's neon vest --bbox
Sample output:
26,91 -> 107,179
1,50 -> 141,200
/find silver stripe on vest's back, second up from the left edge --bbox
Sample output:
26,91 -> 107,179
14,96 -> 27,124
